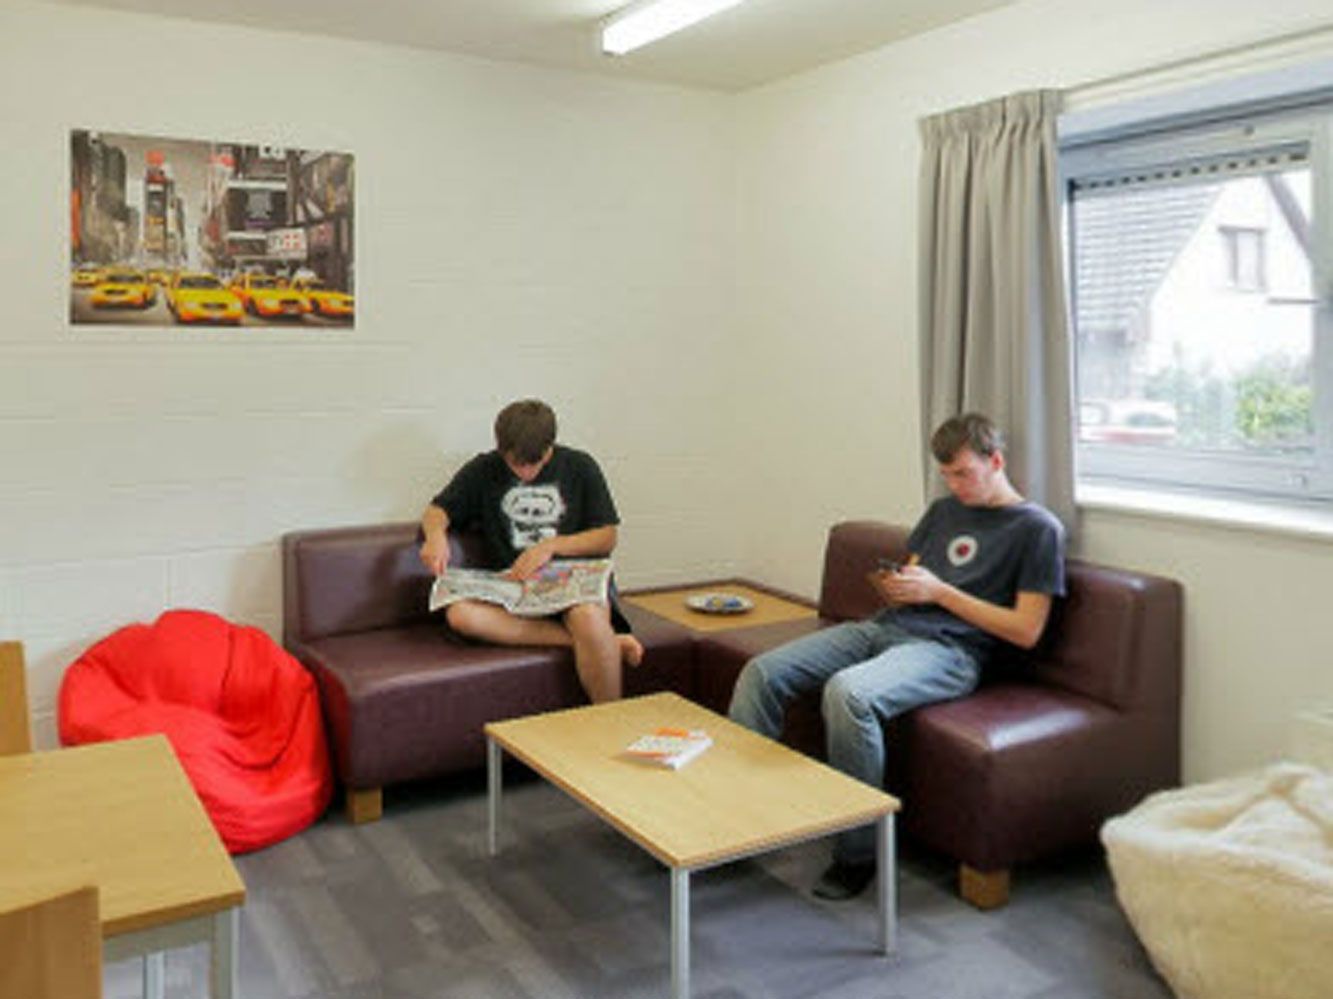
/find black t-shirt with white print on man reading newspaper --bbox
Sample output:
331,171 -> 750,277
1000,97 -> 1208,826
431,444 -> 620,571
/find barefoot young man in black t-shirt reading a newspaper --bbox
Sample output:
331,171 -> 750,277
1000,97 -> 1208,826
421,399 -> 644,703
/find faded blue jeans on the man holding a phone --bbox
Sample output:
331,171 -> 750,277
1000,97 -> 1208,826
728,612 -> 981,863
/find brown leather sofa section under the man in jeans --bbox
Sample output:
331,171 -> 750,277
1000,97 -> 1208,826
696,522 -> 1181,908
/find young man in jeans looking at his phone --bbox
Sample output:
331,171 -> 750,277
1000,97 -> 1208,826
729,413 -> 1065,899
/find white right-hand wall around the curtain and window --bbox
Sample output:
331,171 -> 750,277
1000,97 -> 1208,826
737,0 -> 1333,779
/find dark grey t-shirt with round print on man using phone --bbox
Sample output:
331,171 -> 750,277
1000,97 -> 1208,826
884,496 -> 1065,663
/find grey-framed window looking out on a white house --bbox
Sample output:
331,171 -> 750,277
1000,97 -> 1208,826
1061,104 -> 1333,500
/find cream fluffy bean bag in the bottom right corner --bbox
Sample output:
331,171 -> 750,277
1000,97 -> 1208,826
1101,763 -> 1333,999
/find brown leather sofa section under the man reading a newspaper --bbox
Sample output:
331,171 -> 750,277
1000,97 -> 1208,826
283,524 -> 694,822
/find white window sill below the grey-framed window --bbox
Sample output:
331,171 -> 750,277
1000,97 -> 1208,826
1076,481 -> 1333,542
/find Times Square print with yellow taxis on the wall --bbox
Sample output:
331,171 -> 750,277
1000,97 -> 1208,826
68,129 -> 356,331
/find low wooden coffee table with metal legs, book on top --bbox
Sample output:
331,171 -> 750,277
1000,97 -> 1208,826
485,694 -> 898,999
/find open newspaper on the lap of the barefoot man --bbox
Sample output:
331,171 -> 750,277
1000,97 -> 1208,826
431,559 -> 611,618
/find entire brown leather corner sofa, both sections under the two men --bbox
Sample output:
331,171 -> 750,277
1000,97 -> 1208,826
283,522 -> 1181,907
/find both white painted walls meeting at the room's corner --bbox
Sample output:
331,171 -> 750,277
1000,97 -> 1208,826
0,0 -> 1333,778
